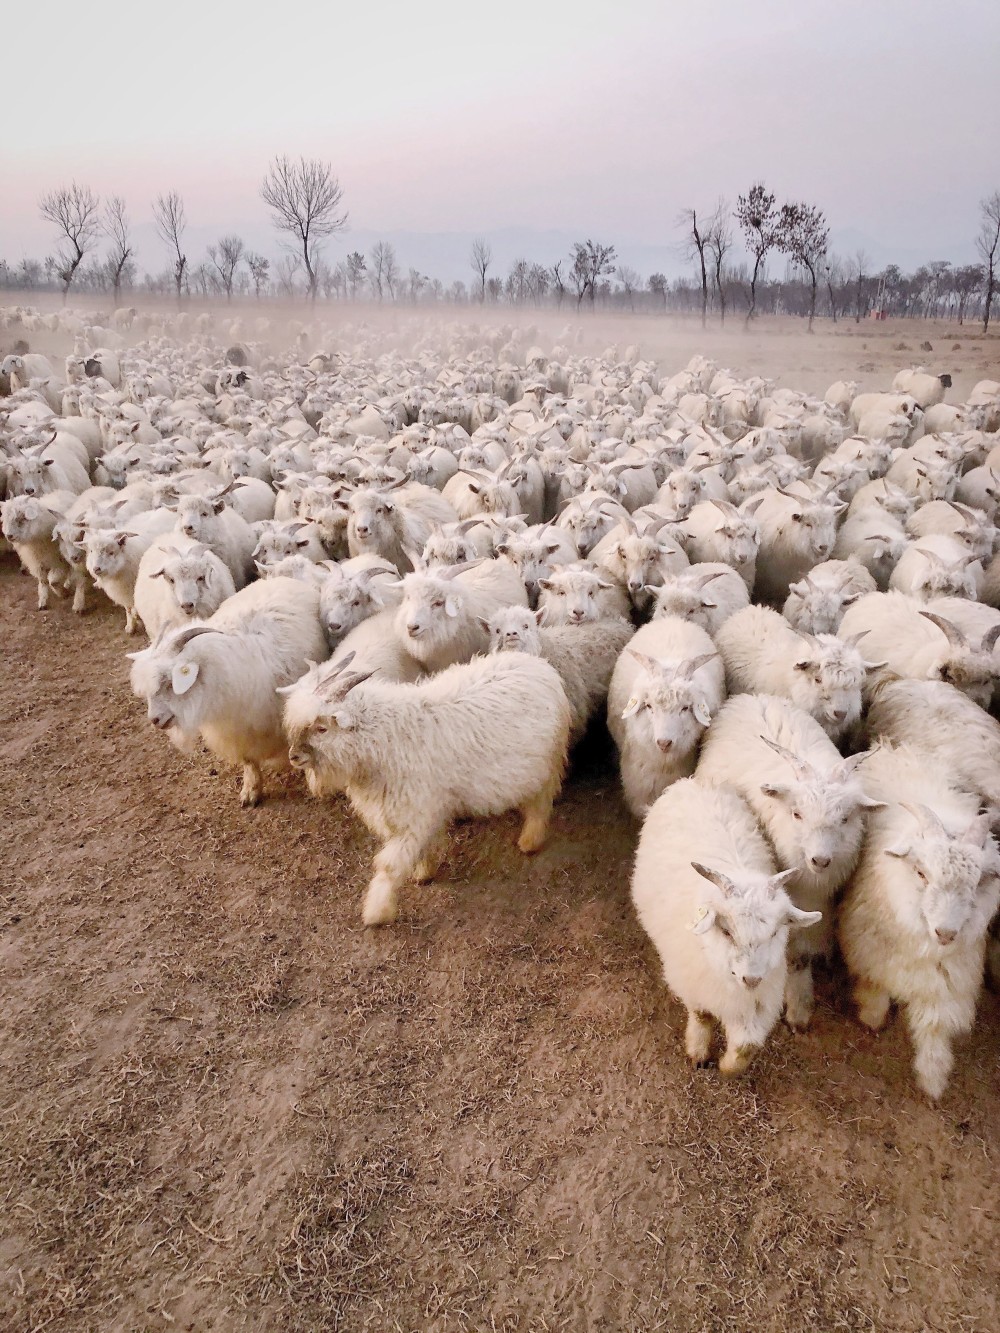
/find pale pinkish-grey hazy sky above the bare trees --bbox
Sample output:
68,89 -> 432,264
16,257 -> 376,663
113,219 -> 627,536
0,0 -> 1000,275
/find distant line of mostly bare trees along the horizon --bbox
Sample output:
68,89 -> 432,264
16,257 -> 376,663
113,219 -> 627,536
0,166 -> 1000,329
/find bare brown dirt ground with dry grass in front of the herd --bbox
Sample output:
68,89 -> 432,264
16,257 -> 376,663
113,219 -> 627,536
0,314 -> 1000,1333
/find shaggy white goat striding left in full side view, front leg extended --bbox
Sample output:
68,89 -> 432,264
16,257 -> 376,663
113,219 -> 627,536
285,653 -> 569,925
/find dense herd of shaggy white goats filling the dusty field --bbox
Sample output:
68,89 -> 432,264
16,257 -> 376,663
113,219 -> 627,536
0,309 -> 1000,1098
